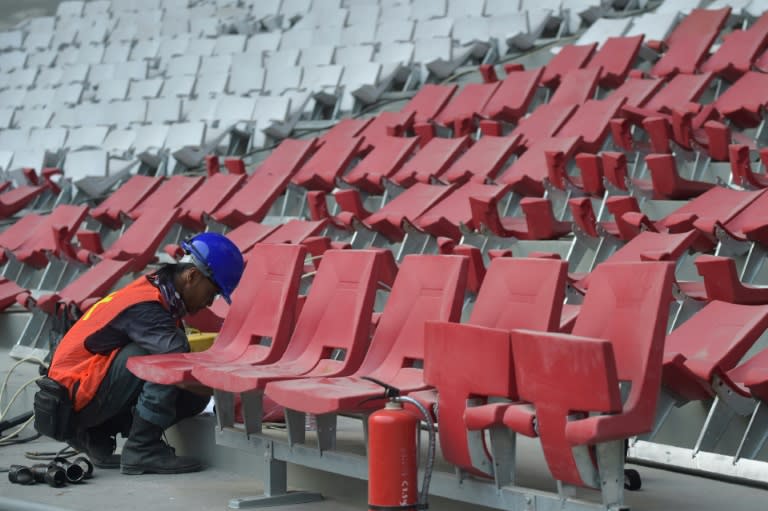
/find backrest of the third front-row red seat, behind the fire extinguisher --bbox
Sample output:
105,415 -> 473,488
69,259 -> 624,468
356,255 -> 468,385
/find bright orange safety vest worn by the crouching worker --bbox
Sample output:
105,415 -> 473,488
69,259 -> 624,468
48,276 -> 168,412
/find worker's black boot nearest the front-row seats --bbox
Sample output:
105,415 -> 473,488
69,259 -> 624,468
120,413 -> 202,475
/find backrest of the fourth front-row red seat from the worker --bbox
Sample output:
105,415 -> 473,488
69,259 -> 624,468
469,257 -> 568,332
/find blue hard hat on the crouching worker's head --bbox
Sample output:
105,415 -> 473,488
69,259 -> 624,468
181,232 -> 245,303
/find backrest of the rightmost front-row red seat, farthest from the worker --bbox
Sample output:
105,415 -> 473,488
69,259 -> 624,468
573,262 -> 674,414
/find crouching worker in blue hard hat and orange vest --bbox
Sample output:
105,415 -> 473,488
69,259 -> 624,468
35,233 -> 244,474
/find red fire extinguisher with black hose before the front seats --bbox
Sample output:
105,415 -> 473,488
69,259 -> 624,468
368,381 -> 435,511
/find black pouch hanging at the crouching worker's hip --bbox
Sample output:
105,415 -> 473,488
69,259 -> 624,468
34,376 -> 75,442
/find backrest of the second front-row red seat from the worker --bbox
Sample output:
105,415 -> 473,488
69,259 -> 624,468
281,250 -> 381,375
